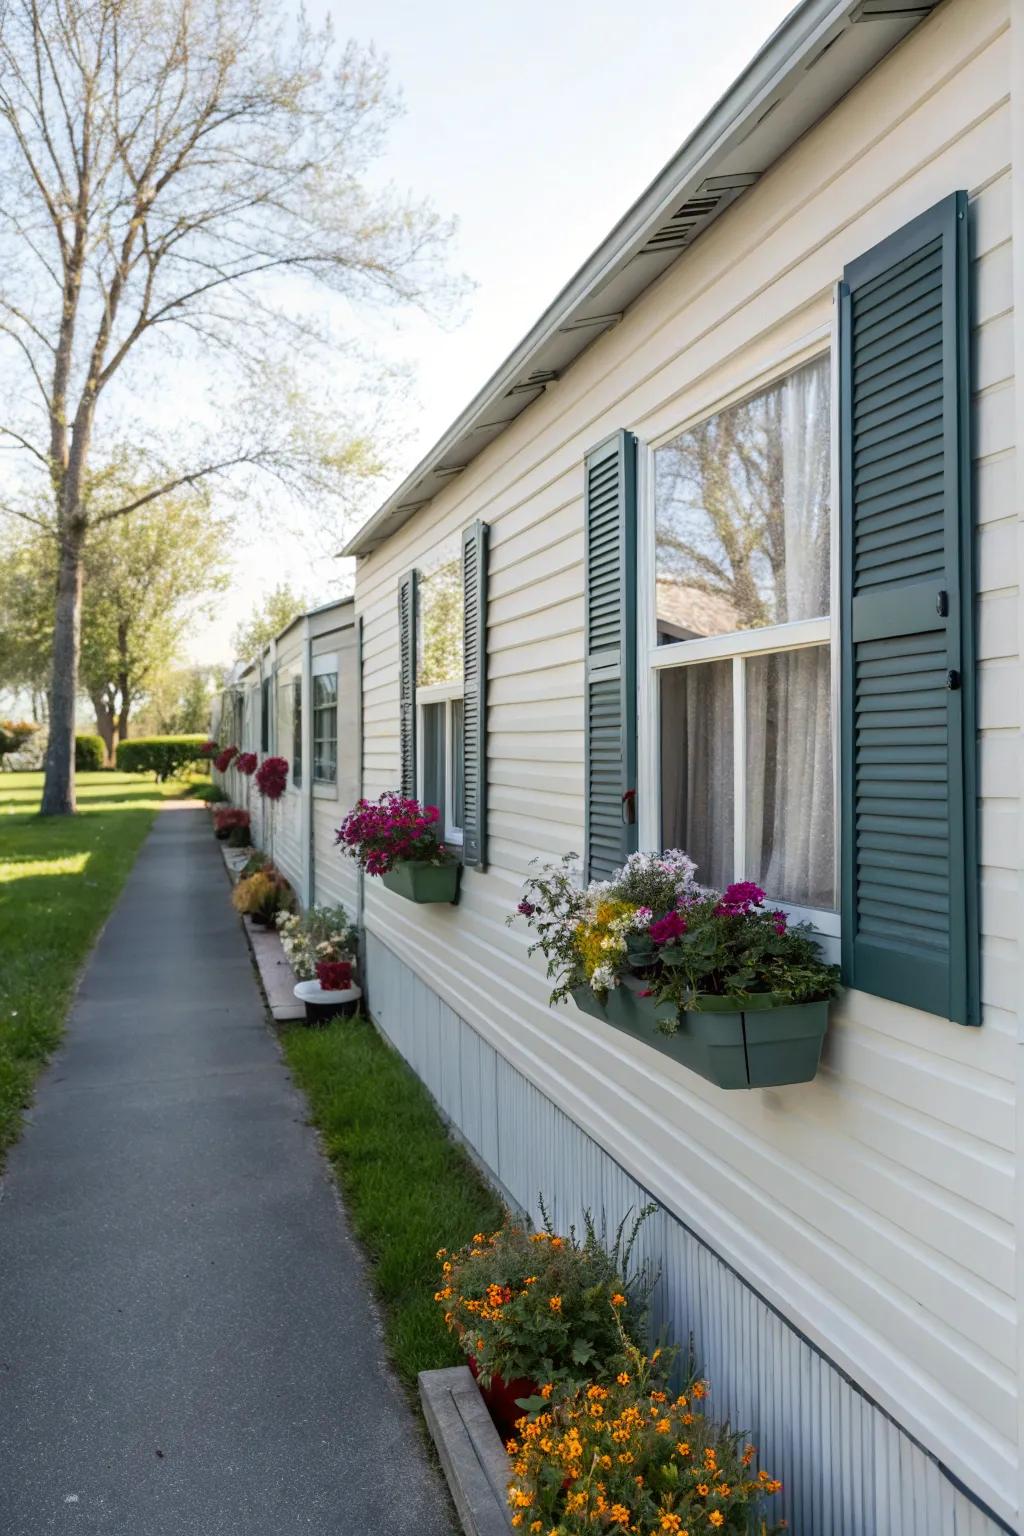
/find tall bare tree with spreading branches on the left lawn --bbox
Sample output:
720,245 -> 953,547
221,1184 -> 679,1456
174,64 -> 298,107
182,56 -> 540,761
0,0 -> 450,814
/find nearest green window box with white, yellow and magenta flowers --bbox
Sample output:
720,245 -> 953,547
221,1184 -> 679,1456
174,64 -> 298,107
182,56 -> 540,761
517,849 -> 838,1089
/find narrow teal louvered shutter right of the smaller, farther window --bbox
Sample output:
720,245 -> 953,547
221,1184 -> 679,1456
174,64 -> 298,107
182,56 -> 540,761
462,522 -> 490,869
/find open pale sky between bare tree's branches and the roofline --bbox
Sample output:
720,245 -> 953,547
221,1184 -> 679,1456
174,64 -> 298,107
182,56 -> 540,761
196,0 -> 792,660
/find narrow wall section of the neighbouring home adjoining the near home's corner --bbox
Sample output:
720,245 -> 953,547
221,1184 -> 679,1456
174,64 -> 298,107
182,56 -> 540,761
313,623 -> 359,922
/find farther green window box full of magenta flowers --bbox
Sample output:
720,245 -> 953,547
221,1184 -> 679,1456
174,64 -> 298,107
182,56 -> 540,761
335,790 -> 462,903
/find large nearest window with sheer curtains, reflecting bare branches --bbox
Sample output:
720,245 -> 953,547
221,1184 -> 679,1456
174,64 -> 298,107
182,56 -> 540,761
649,358 -> 837,926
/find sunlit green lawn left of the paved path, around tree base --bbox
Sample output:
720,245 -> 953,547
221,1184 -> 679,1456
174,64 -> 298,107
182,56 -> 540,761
0,773 -> 183,1164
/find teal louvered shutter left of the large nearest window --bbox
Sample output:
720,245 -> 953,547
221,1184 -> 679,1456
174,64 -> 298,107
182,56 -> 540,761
583,432 -> 637,880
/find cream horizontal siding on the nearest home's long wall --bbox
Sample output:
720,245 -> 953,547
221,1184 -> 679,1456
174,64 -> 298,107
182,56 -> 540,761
356,0 -> 1024,1516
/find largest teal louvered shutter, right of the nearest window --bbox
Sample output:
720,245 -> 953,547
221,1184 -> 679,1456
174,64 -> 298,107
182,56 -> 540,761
840,192 -> 979,1025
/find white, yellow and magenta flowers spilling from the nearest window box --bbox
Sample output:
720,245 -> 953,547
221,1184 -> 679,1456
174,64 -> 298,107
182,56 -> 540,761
508,848 -> 838,1032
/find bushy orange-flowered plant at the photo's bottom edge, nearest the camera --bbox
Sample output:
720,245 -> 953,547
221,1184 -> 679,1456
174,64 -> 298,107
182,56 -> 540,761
507,1339 -> 785,1536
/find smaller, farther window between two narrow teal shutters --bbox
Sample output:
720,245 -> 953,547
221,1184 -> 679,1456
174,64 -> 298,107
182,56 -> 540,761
416,536 -> 465,843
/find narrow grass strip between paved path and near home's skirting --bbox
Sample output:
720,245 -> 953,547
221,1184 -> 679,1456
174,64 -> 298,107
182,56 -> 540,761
282,1018 -> 502,1389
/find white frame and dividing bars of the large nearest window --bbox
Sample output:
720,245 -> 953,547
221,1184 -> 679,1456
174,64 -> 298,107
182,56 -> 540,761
637,330 -> 841,940
